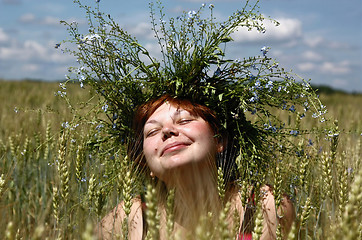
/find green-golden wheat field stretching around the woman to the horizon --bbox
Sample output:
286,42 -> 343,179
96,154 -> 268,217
0,81 -> 362,239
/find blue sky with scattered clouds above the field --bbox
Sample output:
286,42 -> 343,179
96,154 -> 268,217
0,0 -> 362,93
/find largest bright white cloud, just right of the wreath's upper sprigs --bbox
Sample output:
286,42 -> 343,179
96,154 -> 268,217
232,18 -> 302,42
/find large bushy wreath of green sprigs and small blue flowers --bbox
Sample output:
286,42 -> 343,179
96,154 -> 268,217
57,0 -> 326,189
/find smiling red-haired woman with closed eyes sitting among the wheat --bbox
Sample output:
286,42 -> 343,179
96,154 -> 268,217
100,95 -> 294,239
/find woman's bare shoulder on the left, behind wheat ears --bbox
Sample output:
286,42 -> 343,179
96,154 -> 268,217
97,198 -> 143,240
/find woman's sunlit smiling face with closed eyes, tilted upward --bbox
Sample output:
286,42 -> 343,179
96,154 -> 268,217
143,103 -> 222,182
